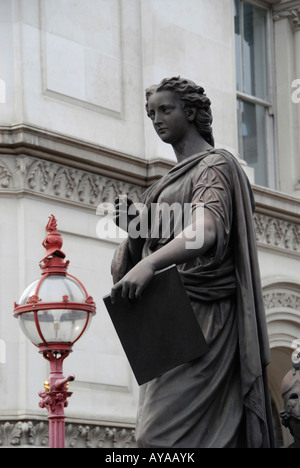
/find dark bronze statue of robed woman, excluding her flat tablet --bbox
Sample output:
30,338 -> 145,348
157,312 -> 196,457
112,77 -> 274,448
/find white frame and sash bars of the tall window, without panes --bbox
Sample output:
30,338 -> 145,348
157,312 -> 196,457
233,0 -> 278,189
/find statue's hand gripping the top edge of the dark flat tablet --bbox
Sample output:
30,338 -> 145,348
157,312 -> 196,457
111,258 -> 155,303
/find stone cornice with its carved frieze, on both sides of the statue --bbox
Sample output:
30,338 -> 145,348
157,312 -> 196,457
0,127 -> 300,257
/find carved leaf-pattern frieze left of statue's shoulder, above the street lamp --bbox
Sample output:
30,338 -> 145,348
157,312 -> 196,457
0,156 -> 142,209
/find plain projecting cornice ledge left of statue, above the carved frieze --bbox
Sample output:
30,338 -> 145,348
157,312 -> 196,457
0,124 -> 174,187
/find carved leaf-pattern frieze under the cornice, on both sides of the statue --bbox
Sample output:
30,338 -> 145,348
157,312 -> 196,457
0,155 -> 300,255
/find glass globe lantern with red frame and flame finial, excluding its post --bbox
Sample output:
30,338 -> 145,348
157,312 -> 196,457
14,217 -> 96,351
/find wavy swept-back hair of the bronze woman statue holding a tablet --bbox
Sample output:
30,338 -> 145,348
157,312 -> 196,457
146,76 -> 215,146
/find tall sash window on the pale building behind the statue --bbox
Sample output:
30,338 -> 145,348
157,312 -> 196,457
234,0 -> 275,188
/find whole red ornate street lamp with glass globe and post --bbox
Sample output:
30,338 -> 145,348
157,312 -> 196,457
14,215 -> 96,448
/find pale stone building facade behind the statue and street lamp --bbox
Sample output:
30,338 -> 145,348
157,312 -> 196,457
0,0 -> 300,447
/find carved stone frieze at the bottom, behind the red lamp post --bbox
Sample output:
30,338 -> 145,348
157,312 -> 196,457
0,420 -> 136,448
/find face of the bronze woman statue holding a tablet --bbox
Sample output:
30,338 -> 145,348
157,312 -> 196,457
148,91 -> 190,144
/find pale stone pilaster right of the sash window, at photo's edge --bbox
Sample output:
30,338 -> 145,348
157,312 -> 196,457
274,1 -> 300,195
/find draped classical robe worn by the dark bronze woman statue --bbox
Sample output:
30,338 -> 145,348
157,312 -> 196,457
112,149 -> 274,448
